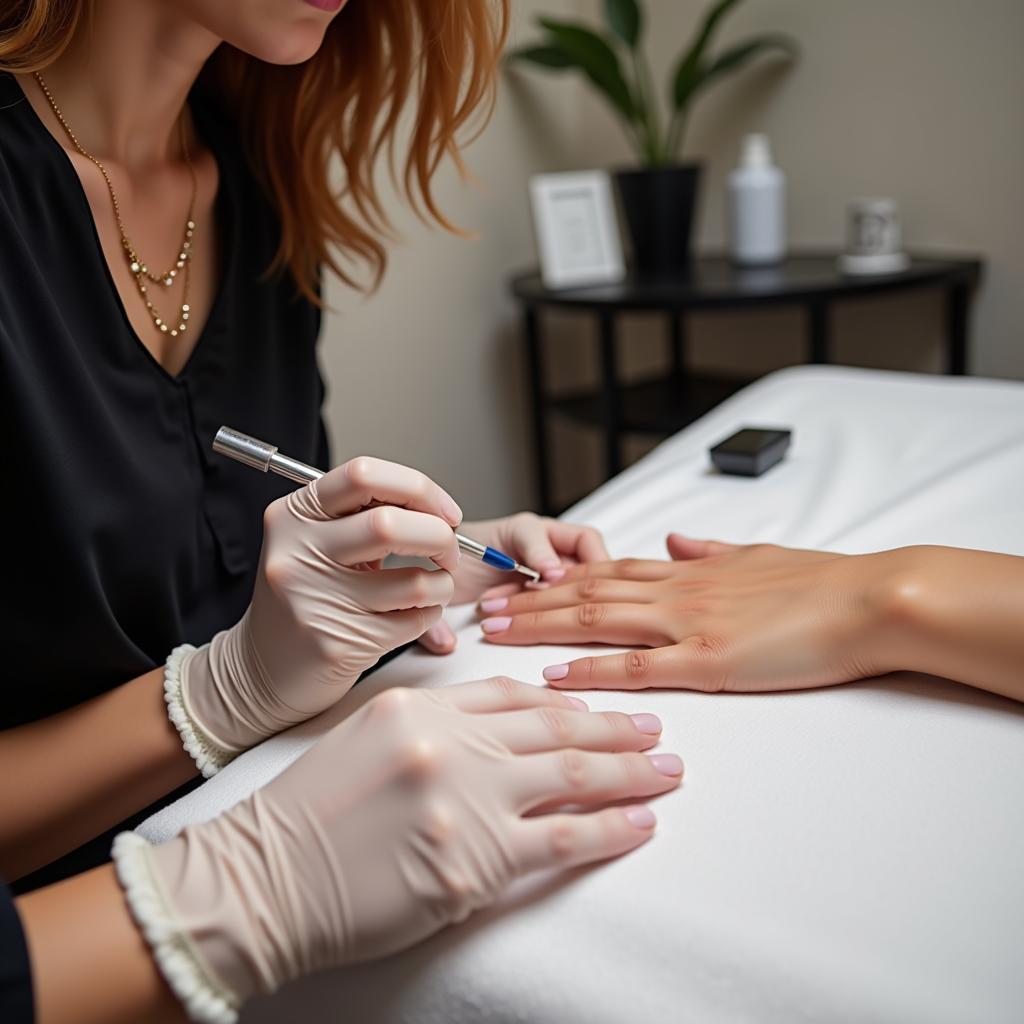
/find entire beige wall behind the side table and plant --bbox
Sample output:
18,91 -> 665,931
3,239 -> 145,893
323,0 -> 1024,515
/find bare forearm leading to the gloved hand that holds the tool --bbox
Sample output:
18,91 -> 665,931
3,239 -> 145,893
0,669 -> 196,879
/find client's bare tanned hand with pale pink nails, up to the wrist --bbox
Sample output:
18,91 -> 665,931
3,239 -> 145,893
481,535 -> 895,691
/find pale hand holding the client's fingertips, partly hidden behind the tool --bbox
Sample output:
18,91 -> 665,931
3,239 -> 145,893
420,512 -> 610,654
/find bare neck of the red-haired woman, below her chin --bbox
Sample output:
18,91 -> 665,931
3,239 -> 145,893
37,0 -> 220,174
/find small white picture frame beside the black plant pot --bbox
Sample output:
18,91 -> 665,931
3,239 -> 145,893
529,171 -> 626,288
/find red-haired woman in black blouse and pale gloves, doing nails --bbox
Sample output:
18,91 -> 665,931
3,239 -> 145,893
0,0 -> 682,1020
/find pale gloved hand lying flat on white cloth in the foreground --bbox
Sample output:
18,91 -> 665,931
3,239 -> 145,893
115,678 -> 683,1021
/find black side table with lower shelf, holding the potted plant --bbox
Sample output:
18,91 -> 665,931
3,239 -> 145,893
511,252 -> 983,514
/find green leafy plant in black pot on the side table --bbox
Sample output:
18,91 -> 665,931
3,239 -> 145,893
508,0 -> 797,274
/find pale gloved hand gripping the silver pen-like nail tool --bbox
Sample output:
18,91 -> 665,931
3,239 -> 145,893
166,458 -> 462,776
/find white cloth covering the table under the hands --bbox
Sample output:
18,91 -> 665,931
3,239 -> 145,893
140,368 -> 1024,1024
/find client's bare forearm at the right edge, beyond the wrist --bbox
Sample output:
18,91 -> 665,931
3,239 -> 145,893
868,547 -> 1024,700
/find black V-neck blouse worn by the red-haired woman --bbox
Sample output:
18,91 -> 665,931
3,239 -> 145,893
0,74 -> 328,880
